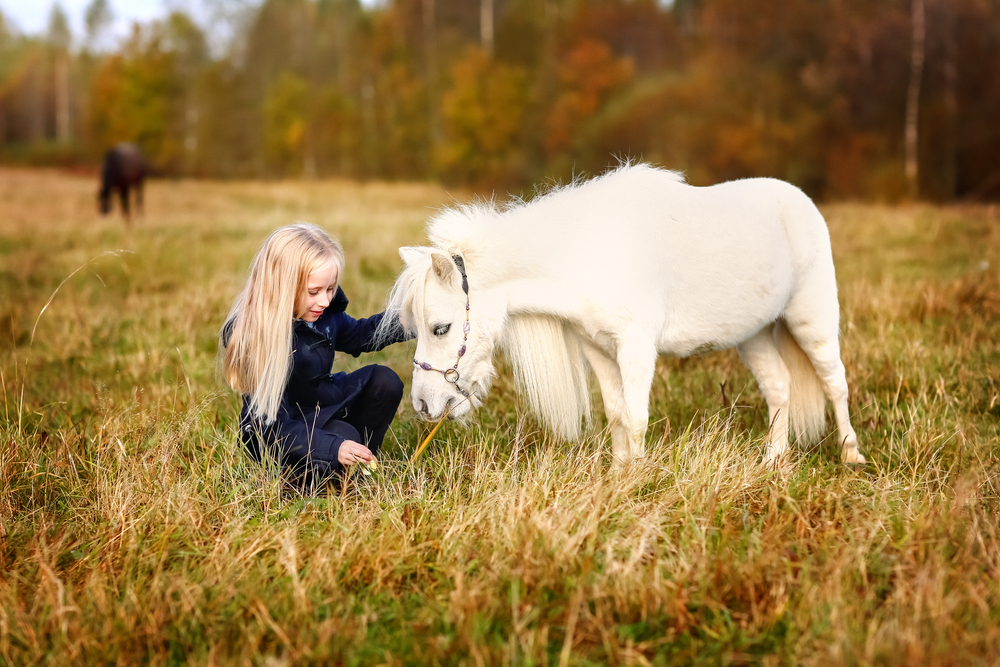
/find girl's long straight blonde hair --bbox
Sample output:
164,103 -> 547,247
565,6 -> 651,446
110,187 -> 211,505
219,223 -> 344,424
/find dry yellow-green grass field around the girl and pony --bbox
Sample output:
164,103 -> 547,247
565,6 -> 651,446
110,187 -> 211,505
0,169 -> 1000,665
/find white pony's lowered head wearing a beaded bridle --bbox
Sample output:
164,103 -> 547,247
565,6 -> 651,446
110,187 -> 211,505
386,247 -> 494,421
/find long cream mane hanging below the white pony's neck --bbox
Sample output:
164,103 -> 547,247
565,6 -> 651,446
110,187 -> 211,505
501,315 -> 590,441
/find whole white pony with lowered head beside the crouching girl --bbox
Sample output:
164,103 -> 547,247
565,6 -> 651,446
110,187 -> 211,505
383,164 -> 865,463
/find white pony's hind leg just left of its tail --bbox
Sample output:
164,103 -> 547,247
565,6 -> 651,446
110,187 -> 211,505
736,324 -> 791,464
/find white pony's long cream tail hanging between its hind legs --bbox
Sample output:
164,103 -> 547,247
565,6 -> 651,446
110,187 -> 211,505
774,320 -> 826,444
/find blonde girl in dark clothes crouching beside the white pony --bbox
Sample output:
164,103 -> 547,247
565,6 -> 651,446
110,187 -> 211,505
219,223 -> 407,485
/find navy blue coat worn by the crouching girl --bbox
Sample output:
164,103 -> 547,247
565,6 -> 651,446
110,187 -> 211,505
240,287 -> 409,475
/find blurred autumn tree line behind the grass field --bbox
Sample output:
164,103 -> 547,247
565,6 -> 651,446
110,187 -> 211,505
0,0 -> 1000,201
